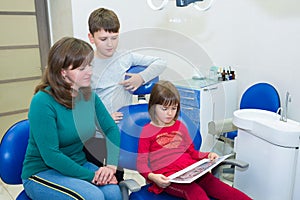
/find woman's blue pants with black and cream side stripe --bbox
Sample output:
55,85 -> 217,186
23,162 -> 122,200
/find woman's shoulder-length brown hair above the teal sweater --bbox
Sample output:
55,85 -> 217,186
35,37 -> 94,109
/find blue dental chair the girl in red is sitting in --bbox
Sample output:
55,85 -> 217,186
118,67 -> 248,200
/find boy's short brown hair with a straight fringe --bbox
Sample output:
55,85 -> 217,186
88,8 -> 120,35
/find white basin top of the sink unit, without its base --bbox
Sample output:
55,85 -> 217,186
233,109 -> 300,147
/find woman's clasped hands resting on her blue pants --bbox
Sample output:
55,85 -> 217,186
92,166 -> 118,185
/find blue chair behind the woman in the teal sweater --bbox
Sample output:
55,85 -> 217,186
0,119 -> 30,200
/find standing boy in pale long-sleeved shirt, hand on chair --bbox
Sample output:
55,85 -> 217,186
87,8 -> 167,181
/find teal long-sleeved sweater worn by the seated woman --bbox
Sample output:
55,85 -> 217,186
22,88 -> 120,181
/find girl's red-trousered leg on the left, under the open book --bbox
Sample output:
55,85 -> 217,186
165,182 -> 209,200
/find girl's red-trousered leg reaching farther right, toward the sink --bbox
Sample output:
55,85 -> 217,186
195,173 -> 251,200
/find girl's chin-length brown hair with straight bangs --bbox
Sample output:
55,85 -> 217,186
148,80 -> 180,123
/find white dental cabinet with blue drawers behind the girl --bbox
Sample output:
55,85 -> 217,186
173,79 -> 237,151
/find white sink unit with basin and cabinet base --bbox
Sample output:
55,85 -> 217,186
233,109 -> 300,200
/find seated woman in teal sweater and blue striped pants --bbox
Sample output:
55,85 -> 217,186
22,37 -> 121,200
